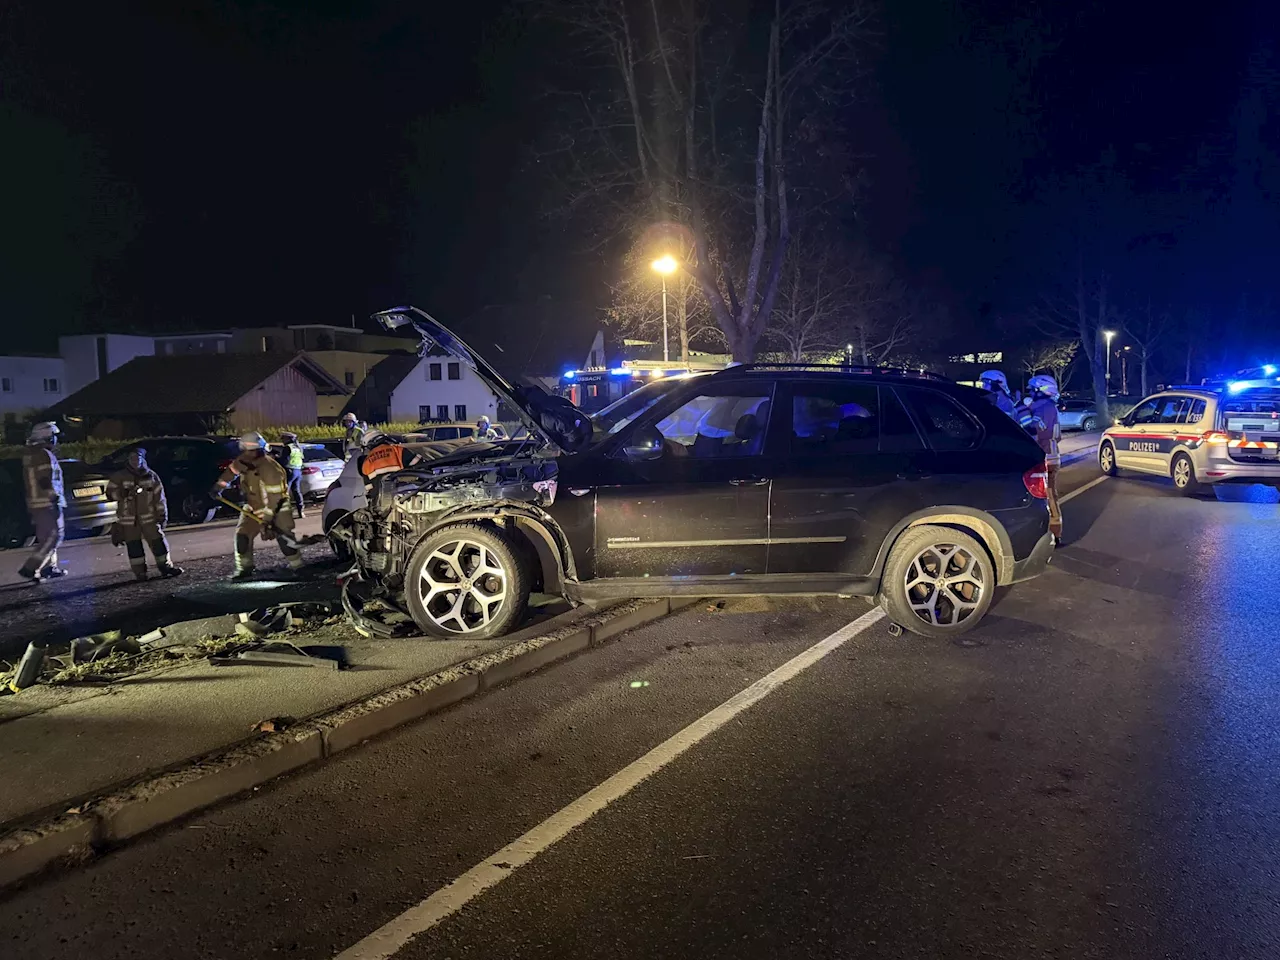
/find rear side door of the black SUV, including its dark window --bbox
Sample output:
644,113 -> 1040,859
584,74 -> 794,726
768,379 -> 924,576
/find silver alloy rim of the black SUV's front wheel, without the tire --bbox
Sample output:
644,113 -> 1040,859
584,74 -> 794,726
419,539 -> 508,634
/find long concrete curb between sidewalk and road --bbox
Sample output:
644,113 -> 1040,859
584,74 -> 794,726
0,598 -> 698,890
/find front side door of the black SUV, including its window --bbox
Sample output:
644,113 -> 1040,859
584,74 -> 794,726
591,380 -> 777,577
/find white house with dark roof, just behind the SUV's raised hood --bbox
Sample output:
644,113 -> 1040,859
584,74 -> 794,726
346,352 -> 504,424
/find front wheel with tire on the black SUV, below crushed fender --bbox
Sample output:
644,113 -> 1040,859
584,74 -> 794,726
404,524 -> 531,640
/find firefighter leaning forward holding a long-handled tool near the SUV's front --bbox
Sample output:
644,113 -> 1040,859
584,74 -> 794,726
209,430 -> 302,580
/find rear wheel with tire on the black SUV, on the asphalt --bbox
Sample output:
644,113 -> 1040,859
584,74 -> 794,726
879,525 -> 996,639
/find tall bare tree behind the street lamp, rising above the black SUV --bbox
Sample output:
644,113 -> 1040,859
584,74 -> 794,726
529,0 -> 868,361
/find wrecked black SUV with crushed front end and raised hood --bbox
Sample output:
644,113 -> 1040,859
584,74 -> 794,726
335,307 -> 1053,637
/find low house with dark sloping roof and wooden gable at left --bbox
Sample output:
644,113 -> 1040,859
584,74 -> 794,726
49,353 -> 348,439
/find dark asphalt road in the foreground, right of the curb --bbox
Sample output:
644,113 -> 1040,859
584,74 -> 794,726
0,462 -> 1280,960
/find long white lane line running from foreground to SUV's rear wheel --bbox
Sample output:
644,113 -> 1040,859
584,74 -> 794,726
337,608 -> 884,960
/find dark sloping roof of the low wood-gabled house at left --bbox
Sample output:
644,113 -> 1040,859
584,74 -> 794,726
51,353 -> 347,416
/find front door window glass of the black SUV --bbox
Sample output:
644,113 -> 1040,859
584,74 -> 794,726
655,390 -> 772,460
